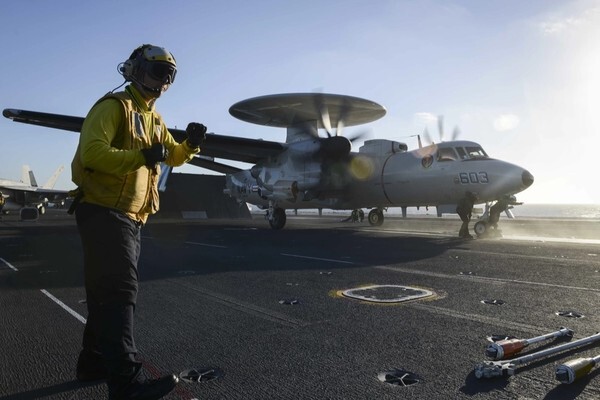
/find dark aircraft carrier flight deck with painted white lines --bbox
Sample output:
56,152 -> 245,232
0,210 -> 600,400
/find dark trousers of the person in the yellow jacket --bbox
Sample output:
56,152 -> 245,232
76,203 -> 141,386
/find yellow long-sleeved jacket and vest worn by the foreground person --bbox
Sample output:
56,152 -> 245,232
71,85 -> 200,223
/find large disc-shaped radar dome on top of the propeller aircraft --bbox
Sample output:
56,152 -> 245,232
229,93 -> 386,128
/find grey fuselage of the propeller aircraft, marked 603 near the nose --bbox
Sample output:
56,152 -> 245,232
226,140 -> 533,214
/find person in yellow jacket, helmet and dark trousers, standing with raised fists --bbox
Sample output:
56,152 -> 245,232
70,44 -> 206,400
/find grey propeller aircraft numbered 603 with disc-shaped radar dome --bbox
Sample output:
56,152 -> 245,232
3,93 -> 533,234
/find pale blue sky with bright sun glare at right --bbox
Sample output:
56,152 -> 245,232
0,0 -> 600,204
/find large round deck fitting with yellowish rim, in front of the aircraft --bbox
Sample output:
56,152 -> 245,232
342,285 -> 434,303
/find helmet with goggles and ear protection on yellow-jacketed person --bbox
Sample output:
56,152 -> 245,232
119,44 -> 177,92
